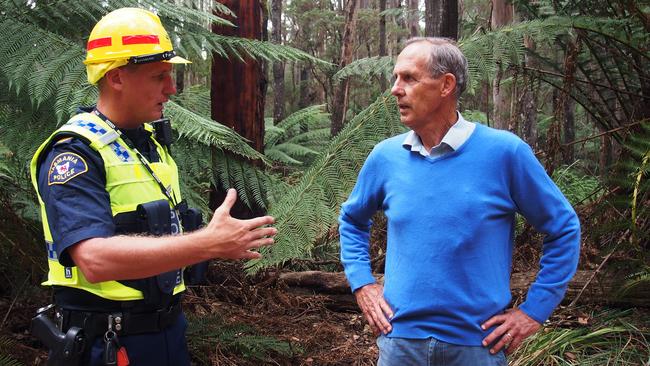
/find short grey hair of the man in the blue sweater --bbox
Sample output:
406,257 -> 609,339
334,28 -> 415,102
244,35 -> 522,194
405,37 -> 468,99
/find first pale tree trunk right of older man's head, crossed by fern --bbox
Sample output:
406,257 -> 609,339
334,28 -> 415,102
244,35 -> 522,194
490,0 -> 512,130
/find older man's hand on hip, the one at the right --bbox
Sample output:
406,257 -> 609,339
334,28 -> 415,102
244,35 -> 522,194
481,309 -> 541,354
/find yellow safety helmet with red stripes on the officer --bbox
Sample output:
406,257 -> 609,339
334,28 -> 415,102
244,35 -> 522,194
84,8 -> 190,84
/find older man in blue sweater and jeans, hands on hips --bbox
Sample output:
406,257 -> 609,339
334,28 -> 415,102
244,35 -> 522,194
339,38 -> 580,366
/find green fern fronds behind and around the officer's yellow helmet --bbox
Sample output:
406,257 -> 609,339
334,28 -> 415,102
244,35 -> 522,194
0,0 -> 321,122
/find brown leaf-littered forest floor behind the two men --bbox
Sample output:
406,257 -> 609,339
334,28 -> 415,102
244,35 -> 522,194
0,247 -> 650,366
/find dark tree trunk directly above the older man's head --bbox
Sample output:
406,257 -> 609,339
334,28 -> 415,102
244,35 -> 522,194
424,0 -> 458,39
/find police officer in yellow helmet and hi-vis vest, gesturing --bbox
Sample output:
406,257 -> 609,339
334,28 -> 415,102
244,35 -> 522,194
31,8 -> 276,365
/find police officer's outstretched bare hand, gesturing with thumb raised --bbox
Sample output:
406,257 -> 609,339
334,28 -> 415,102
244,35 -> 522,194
204,189 -> 278,259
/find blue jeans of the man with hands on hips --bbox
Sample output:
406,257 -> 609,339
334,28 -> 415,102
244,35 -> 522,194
377,335 -> 508,366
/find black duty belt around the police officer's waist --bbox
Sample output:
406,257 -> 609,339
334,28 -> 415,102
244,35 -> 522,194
61,302 -> 182,336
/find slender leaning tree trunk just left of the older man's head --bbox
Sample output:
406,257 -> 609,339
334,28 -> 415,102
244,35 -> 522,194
330,0 -> 359,136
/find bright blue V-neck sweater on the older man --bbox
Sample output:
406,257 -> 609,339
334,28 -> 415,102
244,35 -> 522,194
339,125 -> 580,346
